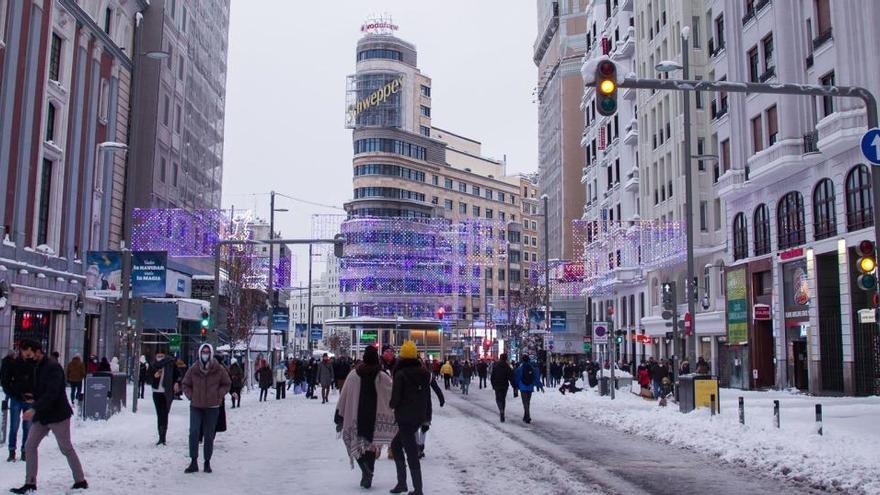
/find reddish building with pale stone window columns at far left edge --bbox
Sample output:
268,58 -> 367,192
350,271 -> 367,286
0,0 -> 148,360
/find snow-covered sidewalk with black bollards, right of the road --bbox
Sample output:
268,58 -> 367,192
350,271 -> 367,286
546,389 -> 880,494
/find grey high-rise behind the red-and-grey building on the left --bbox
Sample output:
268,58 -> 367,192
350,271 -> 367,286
132,0 -> 229,211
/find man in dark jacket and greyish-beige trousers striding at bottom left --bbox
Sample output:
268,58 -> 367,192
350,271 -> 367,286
10,340 -> 89,493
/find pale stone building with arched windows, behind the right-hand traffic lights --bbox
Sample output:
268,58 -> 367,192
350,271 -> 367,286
712,0 -> 880,395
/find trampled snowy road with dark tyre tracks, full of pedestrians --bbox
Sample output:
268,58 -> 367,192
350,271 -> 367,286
0,387 -> 836,495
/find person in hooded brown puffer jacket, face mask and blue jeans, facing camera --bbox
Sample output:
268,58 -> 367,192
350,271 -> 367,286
182,344 -> 231,473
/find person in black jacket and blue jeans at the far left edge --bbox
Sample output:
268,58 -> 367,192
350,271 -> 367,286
3,348 -> 33,462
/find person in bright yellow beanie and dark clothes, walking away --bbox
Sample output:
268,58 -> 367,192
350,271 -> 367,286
391,341 -> 431,495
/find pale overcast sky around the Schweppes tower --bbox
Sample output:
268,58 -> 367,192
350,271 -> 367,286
223,0 -> 537,280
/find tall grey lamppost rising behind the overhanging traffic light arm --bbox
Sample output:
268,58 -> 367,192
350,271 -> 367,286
676,29 -> 697,367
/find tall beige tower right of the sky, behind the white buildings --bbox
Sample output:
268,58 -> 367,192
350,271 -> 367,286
533,0 -> 590,260
